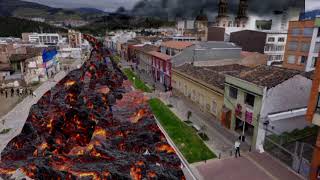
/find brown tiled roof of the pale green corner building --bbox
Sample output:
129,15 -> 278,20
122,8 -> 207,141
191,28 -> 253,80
232,65 -> 303,88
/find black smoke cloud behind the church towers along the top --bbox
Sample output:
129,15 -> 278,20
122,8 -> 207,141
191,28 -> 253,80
132,0 -> 305,18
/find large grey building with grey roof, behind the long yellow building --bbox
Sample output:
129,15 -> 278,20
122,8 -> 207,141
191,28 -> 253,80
172,41 -> 241,66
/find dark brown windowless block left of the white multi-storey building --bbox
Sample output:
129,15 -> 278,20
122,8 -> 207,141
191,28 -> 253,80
230,30 -> 267,53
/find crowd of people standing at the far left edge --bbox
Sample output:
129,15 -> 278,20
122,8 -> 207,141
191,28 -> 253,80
0,87 -> 36,98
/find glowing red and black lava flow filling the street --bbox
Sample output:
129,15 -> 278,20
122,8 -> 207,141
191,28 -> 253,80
0,35 -> 185,180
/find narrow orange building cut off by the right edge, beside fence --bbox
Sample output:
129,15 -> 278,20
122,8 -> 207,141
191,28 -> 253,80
306,54 -> 320,180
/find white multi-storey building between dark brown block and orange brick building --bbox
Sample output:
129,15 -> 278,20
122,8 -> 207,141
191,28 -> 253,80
264,31 -> 287,65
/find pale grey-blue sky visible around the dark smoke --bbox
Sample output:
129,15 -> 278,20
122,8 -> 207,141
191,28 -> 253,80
25,0 -> 320,12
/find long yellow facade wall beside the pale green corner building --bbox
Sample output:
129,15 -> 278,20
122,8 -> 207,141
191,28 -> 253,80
172,71 -> 223,119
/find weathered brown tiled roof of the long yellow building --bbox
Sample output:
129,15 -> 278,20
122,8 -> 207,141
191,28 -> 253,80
174,64 -> 250,89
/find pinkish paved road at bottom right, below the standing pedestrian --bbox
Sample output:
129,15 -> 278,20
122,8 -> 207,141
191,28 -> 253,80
195,152 -> 303,180
